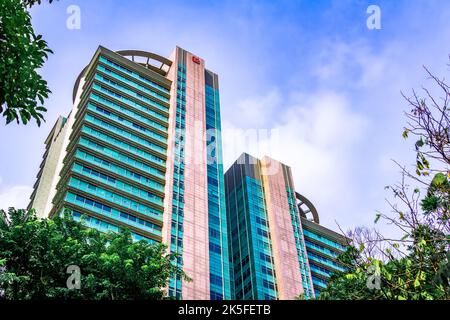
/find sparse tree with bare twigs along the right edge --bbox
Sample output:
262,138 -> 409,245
320,61 -> 450,300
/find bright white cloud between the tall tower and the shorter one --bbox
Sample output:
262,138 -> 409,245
223,92 -> 369,229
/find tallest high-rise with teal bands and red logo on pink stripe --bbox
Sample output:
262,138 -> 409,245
29,47 -> 231,299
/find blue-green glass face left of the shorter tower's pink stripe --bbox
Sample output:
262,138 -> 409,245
225,166 -> 278,300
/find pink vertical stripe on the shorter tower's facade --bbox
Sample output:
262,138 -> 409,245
261,157 -> 303,300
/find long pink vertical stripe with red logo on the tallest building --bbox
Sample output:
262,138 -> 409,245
183,52 -> 210,300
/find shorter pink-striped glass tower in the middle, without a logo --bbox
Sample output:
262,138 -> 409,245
225,153 -> 314,300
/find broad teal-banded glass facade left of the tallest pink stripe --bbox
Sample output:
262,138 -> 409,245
52,49 -> 170,242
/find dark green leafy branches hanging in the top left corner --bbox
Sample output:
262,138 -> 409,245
0,0 -> 53,126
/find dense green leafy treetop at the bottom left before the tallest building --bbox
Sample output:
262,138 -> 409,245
0,208 -> 189,300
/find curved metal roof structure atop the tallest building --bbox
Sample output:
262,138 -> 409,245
72,50 -> 172,102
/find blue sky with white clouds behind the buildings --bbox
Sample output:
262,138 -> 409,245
0,0 -> 450,235
